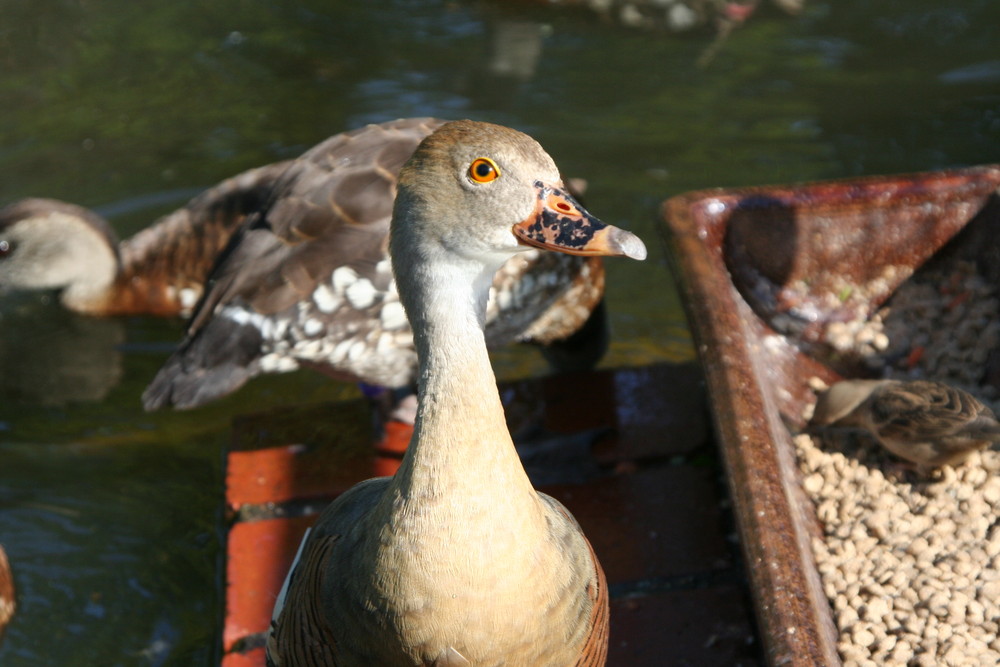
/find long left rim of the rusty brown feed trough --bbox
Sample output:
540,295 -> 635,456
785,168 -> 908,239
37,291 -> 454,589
662,190 -> 842,667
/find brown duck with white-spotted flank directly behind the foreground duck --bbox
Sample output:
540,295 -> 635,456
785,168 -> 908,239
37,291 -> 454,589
142,118 -> 607,414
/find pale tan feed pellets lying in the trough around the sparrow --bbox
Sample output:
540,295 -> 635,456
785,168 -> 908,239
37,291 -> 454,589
794,263 -> 1000,667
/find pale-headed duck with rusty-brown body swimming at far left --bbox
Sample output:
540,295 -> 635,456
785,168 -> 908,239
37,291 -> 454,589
0,172 -> 276,316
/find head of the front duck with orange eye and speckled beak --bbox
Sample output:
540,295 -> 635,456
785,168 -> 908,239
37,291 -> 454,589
391,120 -> 646,294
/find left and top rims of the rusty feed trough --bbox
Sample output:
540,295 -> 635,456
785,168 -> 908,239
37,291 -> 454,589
661,164 -> 1000,666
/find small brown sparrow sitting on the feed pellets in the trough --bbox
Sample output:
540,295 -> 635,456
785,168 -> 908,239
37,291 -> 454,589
809,380 -> 1000,474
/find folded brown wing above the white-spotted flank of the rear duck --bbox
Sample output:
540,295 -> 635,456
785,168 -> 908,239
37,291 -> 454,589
188,119 -> 443,334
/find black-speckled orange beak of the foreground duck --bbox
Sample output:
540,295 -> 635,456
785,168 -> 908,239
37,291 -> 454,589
512,181 -> 646,259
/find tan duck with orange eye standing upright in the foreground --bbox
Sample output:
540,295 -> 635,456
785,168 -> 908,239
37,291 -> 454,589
266,120 -> 646,667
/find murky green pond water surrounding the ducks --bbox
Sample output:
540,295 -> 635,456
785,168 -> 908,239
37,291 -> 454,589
0,0 -> 1000,667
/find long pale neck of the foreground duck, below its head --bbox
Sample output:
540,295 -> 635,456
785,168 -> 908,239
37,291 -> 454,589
393,254 -> 538,529
